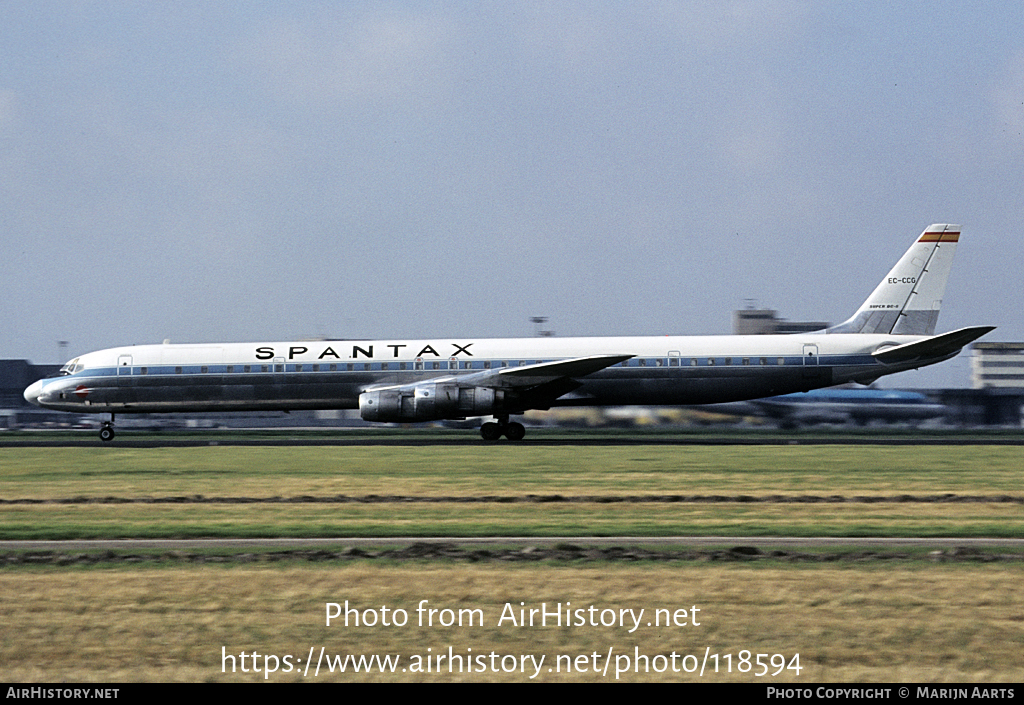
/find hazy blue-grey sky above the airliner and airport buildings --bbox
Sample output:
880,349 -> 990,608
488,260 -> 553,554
0,0 -> 1024,386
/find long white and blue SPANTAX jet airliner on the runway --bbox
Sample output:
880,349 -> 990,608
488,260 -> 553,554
25,224 -> 994,442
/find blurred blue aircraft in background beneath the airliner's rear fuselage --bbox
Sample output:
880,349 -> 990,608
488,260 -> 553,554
701,388 -> 946,428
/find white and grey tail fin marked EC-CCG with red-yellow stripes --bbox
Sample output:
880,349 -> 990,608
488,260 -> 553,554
825,223 -> 959,335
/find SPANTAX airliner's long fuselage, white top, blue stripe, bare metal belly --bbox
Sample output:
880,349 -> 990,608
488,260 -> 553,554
26,333 -> 937,413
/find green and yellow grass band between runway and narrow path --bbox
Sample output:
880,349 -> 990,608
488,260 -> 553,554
0,446 -> 1024,539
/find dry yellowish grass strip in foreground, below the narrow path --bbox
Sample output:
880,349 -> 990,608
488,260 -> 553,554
0,563 -> 1024,685
